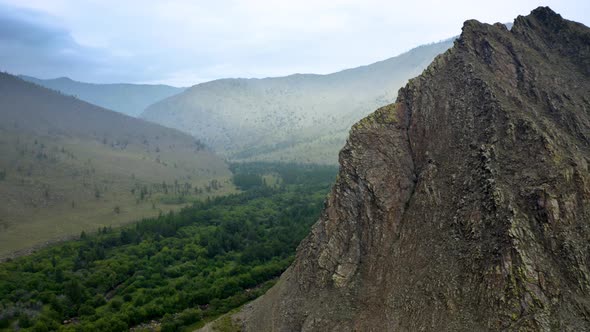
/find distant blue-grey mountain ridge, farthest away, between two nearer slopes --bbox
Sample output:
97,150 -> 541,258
19,75 -> 184,116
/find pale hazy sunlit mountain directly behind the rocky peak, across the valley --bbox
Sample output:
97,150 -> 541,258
141,39 -> 453,164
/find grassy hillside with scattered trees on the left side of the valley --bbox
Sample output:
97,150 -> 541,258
0,73 -> 231,257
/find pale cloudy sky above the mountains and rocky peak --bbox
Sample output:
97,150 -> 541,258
0,0 -> 590,86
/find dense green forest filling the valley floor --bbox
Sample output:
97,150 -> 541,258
0,163 -> 337,331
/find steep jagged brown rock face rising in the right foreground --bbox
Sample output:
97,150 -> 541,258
242,7 -> 590,331
